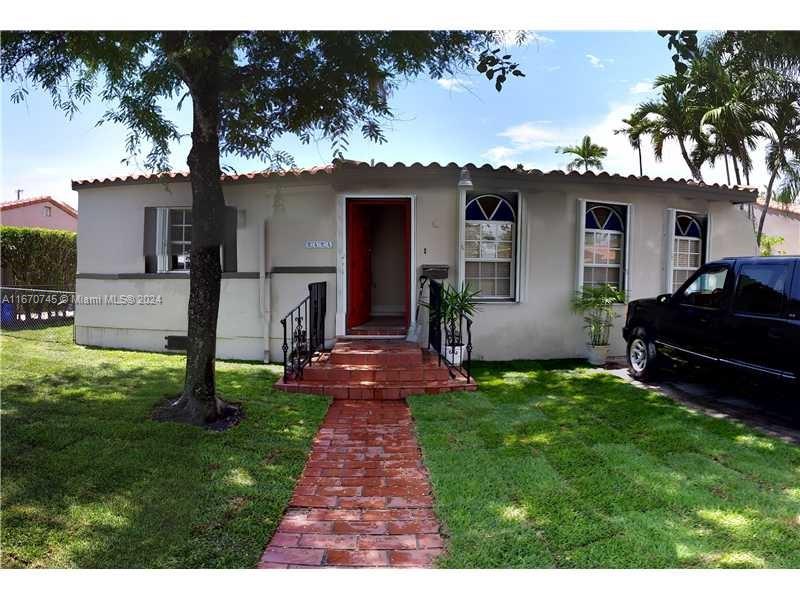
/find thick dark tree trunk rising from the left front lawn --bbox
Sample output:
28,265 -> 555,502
153,58 -> 226,425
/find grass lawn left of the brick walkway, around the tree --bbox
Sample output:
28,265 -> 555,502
0,327 -> 327,568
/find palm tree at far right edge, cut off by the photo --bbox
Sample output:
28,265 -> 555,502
756,94 -> 800,246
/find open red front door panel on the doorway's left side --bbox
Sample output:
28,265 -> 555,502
347,202 -> 372,328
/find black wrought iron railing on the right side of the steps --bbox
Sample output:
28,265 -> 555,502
427,279 -> 472,381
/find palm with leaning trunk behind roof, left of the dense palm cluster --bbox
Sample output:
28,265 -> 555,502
633,75 -> 703,182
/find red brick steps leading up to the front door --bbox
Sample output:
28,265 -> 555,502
275,339 -> 477,400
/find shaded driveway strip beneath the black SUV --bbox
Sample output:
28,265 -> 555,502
606,365 -> 800,444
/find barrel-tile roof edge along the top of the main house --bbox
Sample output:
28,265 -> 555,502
72,160 -> 758,202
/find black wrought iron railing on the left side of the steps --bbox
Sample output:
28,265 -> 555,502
281,281 -> 327,380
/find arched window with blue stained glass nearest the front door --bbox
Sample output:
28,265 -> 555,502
464,193 -> 518,300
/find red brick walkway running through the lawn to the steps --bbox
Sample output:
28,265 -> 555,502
259,400 -> 443,568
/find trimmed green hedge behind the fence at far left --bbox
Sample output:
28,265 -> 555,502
0,226 -> 78,290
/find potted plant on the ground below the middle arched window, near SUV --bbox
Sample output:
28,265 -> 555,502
572,284 -> 625,365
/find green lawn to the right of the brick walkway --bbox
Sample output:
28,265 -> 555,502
410,361 -> 800,567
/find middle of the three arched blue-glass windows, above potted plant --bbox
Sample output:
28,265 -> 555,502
581,202 -> 628,290
